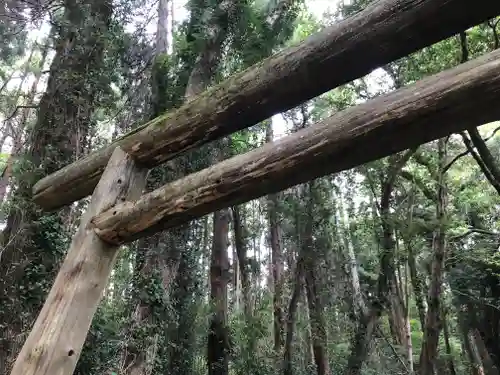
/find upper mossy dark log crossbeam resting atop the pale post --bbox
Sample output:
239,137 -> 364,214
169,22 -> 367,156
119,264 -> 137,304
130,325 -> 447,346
33,0 -> 500,209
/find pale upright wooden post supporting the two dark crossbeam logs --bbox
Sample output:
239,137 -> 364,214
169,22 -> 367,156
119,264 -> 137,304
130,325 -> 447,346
11,148 -> 147,375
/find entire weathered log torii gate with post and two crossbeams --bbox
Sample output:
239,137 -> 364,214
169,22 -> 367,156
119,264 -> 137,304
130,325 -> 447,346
11,0 -> 500,375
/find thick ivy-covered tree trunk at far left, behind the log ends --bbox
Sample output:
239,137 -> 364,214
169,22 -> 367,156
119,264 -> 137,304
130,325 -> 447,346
0,0 -> 112,373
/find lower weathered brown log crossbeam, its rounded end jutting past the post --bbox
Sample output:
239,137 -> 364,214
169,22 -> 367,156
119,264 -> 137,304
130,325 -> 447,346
92,51 -> 500,243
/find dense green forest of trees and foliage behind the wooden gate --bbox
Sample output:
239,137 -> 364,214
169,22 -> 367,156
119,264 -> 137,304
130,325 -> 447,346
0,0 -> 500,375
